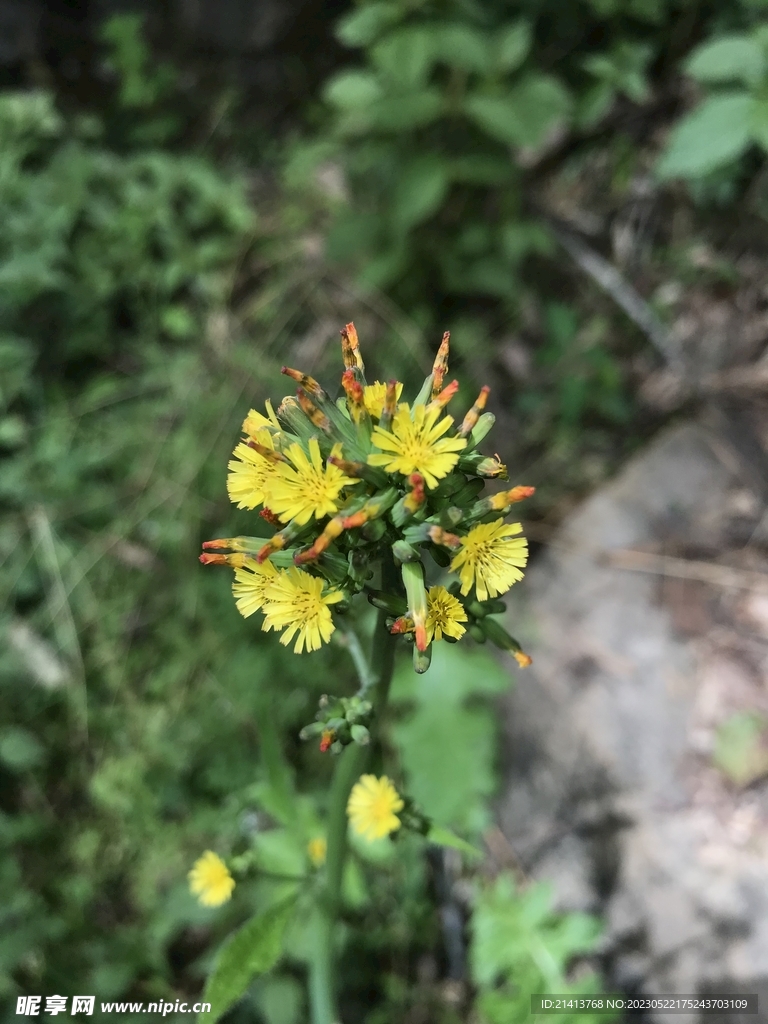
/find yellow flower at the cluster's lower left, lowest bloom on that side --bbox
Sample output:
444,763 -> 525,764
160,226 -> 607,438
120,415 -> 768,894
262,566 -> 344,654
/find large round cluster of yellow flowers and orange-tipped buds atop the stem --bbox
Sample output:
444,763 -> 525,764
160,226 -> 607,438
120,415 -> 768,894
201,324 -> 532,671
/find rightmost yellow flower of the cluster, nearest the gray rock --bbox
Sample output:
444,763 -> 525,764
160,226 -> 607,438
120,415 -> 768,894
451,519 -> 528,601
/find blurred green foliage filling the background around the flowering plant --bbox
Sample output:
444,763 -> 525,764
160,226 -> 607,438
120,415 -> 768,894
0,0 -> 768,1024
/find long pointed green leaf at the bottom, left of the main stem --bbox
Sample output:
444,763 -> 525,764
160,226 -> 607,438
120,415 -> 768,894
203,899 -> 295,1024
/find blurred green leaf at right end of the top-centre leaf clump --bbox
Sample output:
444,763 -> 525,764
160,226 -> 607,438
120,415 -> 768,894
465,75 -> 570,147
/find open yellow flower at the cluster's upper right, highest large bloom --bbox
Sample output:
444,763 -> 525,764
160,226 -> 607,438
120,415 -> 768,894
368,401 -> 467,487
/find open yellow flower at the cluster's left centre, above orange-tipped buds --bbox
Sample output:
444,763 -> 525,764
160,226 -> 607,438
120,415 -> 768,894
265,437 -> 360,526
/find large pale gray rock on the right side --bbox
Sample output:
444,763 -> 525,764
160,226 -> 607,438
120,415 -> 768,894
499,423 -> 768,1024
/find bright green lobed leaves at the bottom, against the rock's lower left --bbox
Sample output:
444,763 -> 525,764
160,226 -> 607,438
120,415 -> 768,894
470,874 -> 615,1024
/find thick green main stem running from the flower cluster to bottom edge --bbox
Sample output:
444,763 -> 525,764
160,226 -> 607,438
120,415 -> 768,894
309,563 -> 396,1024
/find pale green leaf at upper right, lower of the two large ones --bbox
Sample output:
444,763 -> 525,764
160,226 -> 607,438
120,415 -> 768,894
656,91 -> 754,178
